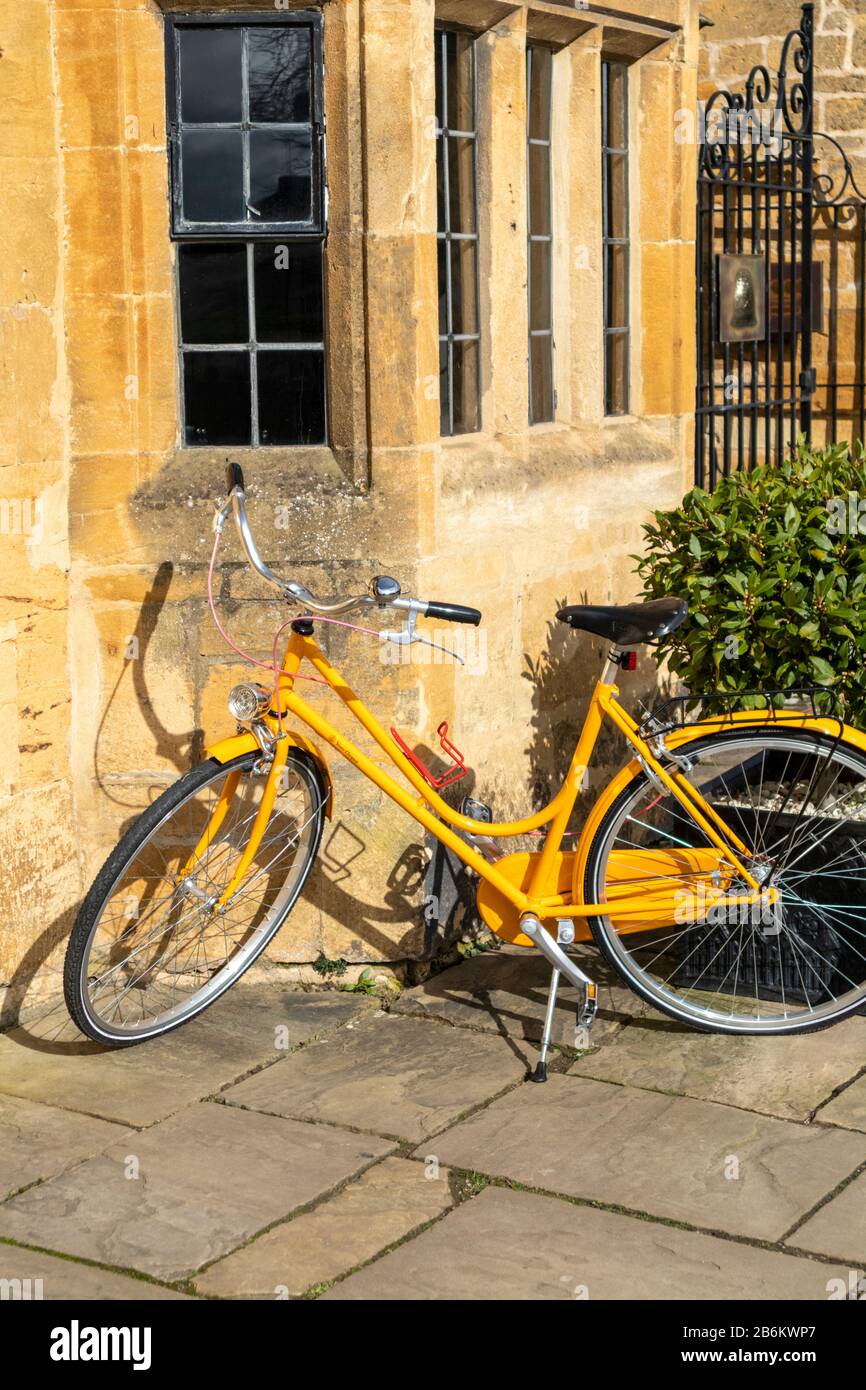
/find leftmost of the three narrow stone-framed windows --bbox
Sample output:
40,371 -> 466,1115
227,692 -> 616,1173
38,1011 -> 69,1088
435,29 -> 481,435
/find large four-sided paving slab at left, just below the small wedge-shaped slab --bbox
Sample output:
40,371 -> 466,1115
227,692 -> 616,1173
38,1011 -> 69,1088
0,1104 -> 391,1280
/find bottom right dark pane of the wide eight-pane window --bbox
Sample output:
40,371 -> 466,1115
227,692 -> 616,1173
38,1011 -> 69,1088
257,350 -> 325,445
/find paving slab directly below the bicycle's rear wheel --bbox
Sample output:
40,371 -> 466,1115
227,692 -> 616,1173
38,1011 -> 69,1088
570,1019 -> 866,1120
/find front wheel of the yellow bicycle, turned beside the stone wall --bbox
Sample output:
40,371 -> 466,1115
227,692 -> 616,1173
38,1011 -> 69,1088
64,749 -> 327,1047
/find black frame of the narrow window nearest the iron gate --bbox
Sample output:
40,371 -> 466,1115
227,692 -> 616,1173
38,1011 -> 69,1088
602,58 -> 631,416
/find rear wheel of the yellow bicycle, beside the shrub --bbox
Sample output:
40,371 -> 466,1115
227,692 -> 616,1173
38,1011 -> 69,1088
584,727 -> 866,1034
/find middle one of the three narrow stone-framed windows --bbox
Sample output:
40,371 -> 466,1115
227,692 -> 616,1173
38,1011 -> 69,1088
527,43 -> 556,425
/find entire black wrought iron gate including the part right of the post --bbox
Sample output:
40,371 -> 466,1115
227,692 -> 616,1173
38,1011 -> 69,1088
695,4 -> 866,488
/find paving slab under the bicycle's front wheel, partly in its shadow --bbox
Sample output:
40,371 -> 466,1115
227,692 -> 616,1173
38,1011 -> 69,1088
0,984 -> 373,1127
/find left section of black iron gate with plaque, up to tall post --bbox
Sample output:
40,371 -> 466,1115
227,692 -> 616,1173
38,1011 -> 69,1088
695,4 -> 815,488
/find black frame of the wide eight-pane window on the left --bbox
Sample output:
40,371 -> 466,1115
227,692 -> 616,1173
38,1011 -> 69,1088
165,10 -> 329,449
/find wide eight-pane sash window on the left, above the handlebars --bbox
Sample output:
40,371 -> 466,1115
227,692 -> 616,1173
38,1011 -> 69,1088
167,15 -> 327,445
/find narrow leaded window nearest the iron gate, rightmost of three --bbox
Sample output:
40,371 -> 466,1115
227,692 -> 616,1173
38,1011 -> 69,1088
602,63 -> 630,416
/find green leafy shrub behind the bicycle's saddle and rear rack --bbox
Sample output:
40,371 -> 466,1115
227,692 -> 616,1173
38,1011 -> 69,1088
635,441 -> 866,724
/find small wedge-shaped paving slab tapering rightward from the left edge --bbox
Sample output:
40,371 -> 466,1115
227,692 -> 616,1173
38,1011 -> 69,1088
0,1095 -> 132,1201
